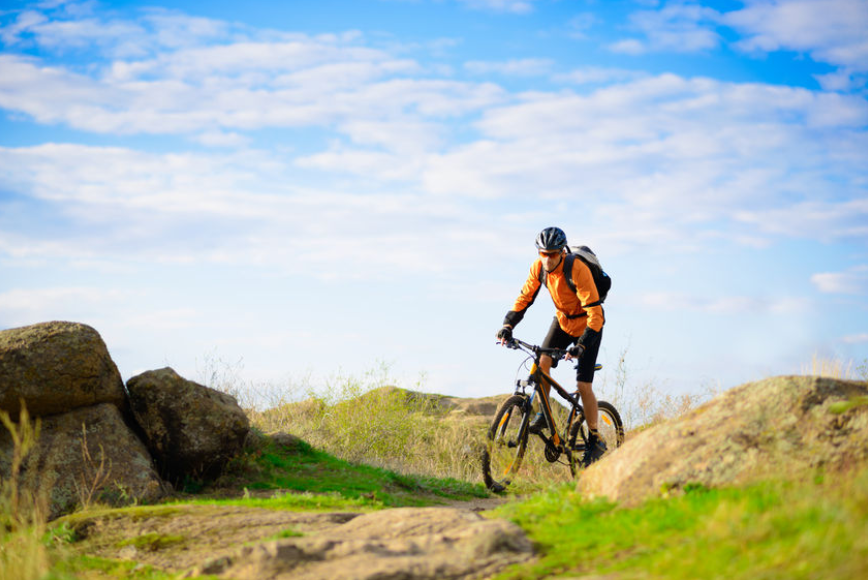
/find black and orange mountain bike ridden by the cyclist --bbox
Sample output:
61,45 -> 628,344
482,338 -> 624,492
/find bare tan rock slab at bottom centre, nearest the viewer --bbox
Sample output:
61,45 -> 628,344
190,508 -> 533,580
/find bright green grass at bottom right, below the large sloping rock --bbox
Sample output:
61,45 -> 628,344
496,471 -> 868,580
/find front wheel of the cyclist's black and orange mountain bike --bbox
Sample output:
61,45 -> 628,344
482,395 -> 530,492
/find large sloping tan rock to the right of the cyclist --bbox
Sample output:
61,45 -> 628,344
578,377 -> 868,504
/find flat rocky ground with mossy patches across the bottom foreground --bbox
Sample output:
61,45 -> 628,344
69,498 -> 533,580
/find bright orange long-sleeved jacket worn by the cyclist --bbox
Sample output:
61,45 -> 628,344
505,258 -> 605,336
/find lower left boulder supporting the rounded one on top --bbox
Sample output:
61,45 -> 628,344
0,403 -> 168,518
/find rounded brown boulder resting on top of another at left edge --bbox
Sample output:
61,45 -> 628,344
0,322 -> 125,418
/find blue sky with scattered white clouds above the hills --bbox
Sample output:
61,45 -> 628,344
0,0 -> 868,406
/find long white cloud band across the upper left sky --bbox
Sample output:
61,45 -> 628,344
0,45 -> 504,133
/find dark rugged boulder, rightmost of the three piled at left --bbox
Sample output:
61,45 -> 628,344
127,368 -> 250,483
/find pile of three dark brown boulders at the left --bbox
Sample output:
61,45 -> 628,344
0,322 -> 249,516
